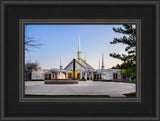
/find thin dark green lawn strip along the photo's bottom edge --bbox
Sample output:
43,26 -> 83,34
25,94 -> 110,97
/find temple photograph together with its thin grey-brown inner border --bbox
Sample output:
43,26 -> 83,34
19,19 -> 140,102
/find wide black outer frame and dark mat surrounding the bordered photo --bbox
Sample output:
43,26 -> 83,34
1,0 -> 160,121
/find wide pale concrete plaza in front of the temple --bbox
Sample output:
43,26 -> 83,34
25,81 -> 136,97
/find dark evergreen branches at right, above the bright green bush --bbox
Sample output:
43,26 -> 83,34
110,24 -> 136,65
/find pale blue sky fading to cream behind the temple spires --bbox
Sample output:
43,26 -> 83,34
25,25 -> 129,69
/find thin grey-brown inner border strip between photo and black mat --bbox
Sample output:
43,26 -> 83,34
19,19 -> 141,102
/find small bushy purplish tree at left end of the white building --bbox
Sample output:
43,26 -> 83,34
25,60 -> 41,70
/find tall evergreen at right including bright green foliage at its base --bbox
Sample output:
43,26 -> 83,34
110,24 -> 136,79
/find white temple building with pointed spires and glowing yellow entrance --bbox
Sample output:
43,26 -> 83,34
26,36 -> 122,80
